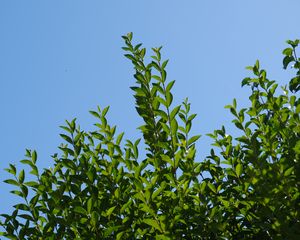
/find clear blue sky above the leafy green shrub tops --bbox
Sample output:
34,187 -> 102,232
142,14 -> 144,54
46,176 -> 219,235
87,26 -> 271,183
0,0 -> 300,223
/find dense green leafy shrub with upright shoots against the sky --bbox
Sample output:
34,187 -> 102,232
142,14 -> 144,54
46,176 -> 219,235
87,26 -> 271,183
1,33 -> 300,239
